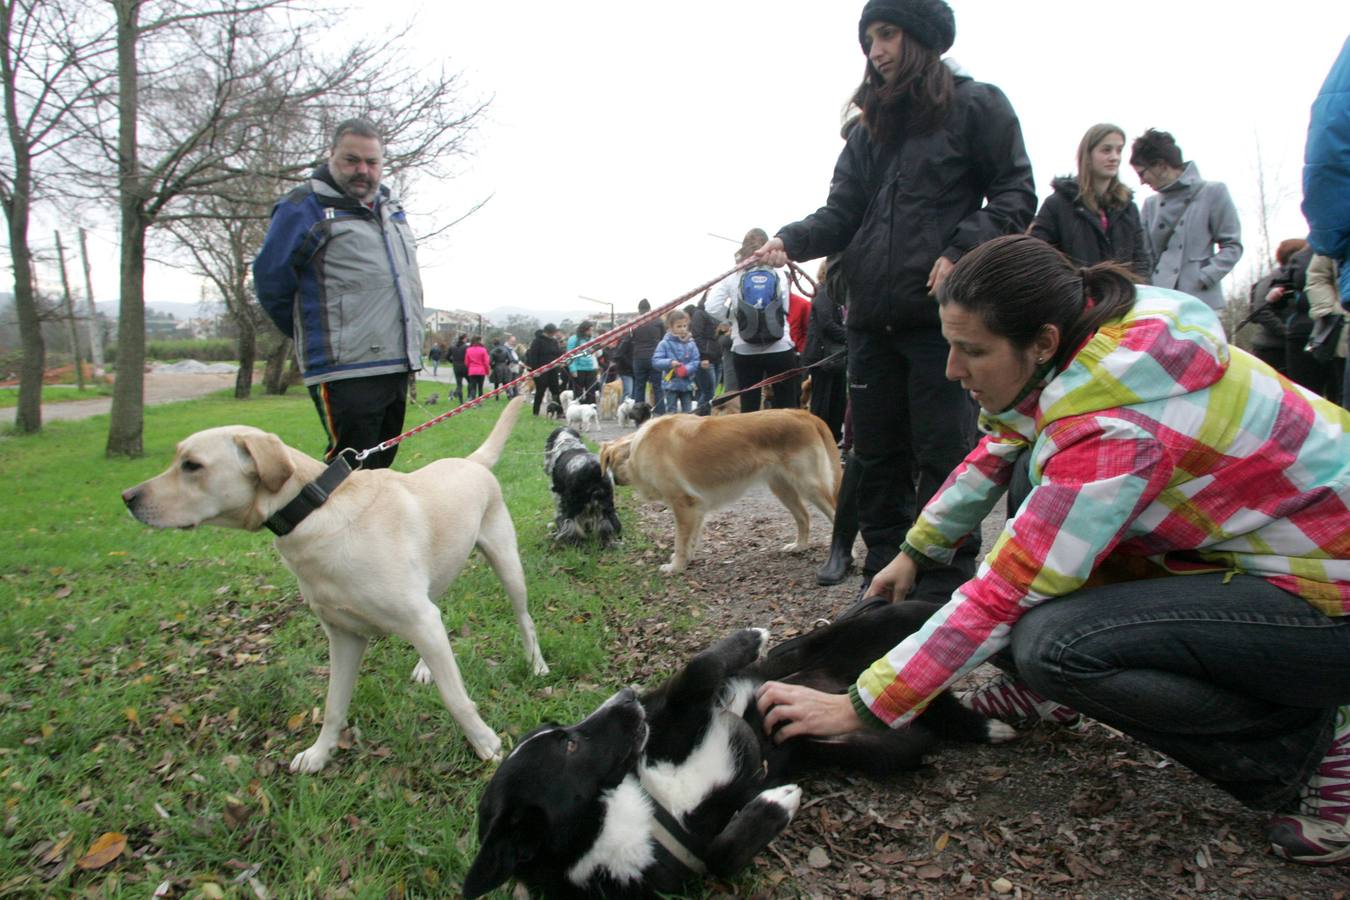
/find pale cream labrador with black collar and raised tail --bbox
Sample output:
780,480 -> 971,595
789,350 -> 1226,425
122,397 -> 548,772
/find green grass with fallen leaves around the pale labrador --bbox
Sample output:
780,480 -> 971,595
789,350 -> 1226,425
0,386 -> 679,899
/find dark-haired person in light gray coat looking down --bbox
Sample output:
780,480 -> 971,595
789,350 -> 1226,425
1130,128 -> 1242,309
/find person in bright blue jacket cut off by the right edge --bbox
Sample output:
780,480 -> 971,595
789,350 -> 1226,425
1303,38 -> 1350,409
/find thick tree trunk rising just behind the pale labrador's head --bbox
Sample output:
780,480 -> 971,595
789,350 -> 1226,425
107,0 -> 146,456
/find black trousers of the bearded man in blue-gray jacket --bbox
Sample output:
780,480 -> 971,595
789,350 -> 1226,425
309,372 -> 409,468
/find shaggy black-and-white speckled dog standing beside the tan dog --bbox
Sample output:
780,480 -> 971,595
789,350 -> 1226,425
544,428 -> 624,546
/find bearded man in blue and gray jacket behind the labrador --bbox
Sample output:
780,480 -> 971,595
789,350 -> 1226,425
254,119 -> 423,468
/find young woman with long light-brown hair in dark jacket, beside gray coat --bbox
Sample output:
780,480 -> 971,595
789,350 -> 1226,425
1031,124 -> 1153,281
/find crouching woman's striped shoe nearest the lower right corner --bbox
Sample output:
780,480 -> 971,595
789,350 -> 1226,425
1266,706 -> 1350,865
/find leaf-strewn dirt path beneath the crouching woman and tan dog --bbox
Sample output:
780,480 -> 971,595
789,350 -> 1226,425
591,415 -> 1350,900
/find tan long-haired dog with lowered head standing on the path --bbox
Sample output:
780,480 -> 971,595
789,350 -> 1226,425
599,409 -> 841,572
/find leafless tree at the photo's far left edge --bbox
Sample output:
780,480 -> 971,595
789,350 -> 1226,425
0,0 -> 112,433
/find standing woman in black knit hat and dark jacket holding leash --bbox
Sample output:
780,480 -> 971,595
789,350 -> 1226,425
755,0 -> 1035,592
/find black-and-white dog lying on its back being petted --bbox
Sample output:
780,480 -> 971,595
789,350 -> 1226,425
464,600 -> 1014,897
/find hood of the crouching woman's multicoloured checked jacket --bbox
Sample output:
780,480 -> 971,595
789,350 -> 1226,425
980,286 -> 1229,441
